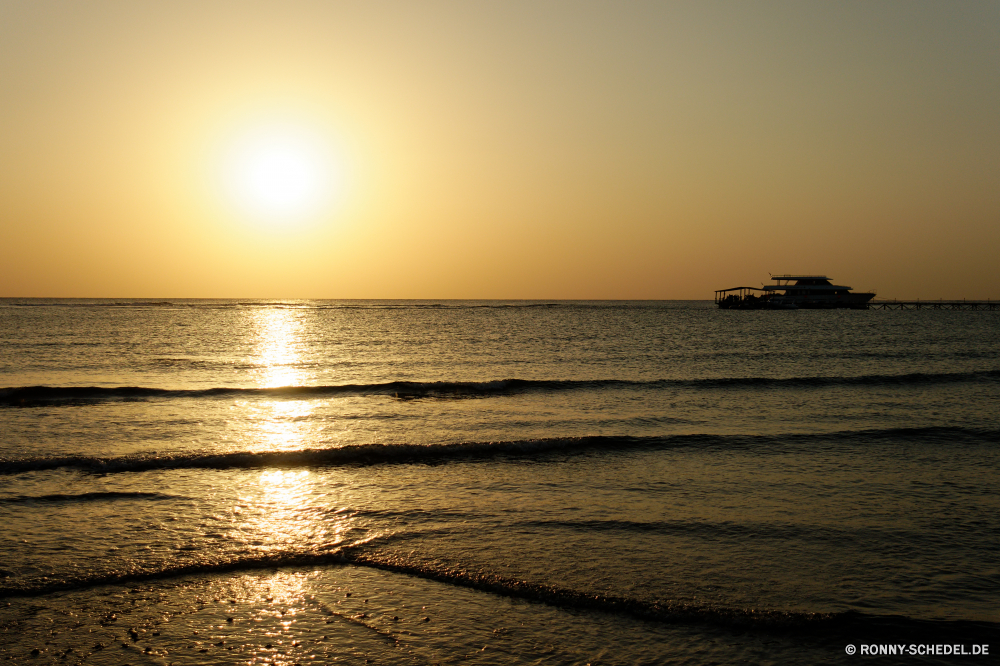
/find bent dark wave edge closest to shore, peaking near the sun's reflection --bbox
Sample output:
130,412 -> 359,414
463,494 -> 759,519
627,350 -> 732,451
0,540 -> 1000,642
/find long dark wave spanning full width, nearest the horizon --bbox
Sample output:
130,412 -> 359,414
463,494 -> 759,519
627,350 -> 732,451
0,370 -> 1000,407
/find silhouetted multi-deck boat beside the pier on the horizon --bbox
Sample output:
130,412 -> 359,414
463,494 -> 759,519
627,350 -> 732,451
715,274 -> 875,310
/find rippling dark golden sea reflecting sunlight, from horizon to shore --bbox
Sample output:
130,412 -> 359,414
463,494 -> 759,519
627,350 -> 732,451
0,299 -> 1000,666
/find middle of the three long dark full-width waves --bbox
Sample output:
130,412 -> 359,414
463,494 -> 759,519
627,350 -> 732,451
0,426 -> 1000,476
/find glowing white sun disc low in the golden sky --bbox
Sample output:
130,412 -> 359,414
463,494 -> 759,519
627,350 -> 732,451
221,124 -> 343,225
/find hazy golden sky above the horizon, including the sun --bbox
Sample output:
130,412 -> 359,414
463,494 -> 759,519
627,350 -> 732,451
0,0 -> 1000,299
